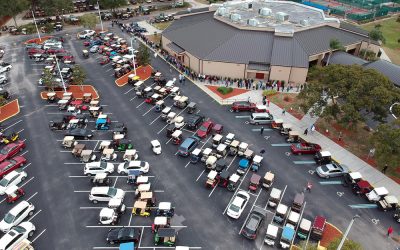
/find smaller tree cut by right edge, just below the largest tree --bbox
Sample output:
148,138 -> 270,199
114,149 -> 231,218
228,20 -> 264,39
371,120 -> 400,169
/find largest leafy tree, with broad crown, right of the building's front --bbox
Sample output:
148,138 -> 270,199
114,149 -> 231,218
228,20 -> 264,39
299,65 -> 400,127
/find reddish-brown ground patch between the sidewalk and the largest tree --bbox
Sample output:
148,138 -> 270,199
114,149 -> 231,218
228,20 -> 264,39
267,92 -> 304,119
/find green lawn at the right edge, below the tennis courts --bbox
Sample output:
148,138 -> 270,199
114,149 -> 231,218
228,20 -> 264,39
361,16 -> 400,64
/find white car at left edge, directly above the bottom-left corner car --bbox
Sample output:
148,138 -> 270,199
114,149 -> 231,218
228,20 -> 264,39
0,201 -> 35,233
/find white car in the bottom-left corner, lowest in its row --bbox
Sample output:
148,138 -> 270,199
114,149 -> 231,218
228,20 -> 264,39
0,221 -> 36,250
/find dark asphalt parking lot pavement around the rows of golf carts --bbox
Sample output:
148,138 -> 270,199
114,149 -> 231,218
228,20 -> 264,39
0,25 -> 398,249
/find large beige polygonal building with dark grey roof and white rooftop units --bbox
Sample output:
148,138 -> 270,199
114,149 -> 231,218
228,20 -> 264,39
162,0 -> 379,84
